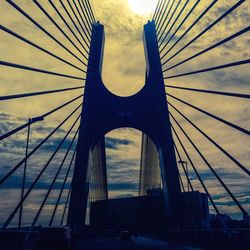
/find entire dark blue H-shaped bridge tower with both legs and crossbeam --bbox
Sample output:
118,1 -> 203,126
68,21 -> 181,231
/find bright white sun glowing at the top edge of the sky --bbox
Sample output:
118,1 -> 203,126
128,0 -> 158,15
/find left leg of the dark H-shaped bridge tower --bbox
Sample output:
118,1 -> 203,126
67,23 -> 104,232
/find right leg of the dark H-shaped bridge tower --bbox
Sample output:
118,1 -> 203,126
144,21 -> 181,227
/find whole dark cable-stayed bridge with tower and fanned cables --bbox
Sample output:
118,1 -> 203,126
0,0 -> 250,249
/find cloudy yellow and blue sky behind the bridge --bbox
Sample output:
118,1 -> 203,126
0,0 -> 250,227
